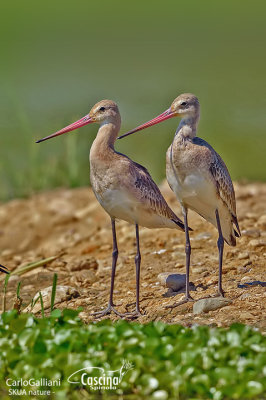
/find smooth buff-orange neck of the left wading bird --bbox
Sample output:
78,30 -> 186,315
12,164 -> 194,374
90,121 -> 120,159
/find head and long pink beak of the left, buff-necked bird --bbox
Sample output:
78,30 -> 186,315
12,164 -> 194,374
36,100 -> 121,143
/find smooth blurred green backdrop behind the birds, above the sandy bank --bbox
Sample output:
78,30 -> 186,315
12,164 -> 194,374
0,0 -> 266,200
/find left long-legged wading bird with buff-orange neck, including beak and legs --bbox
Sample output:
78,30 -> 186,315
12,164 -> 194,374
37,100 -> 184,316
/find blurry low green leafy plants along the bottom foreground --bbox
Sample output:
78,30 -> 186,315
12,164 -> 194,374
0,309 -> 266,400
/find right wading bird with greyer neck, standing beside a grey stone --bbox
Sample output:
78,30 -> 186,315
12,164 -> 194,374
119,93 -> 241,307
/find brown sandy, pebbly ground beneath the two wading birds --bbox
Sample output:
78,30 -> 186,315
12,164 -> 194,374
0,183 -> 266,331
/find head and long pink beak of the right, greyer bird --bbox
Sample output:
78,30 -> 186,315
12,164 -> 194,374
118,93 -> 200,139
